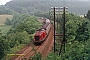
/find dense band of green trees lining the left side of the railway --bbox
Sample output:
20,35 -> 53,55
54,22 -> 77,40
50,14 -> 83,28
0,14 -> 42,60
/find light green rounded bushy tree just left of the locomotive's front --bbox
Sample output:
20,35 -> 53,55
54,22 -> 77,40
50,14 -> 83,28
7,31 -> 31,48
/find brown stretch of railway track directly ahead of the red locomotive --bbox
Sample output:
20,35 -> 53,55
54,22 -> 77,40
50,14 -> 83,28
10,46 -> 40,60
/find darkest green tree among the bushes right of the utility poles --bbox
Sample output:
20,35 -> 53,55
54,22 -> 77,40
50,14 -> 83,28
76,22 -> 89,41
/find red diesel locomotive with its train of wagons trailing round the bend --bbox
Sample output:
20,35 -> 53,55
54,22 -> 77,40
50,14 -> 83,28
34,19 -> 51,44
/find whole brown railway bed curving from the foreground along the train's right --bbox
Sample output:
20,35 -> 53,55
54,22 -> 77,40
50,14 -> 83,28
11,18 -> 54,60
